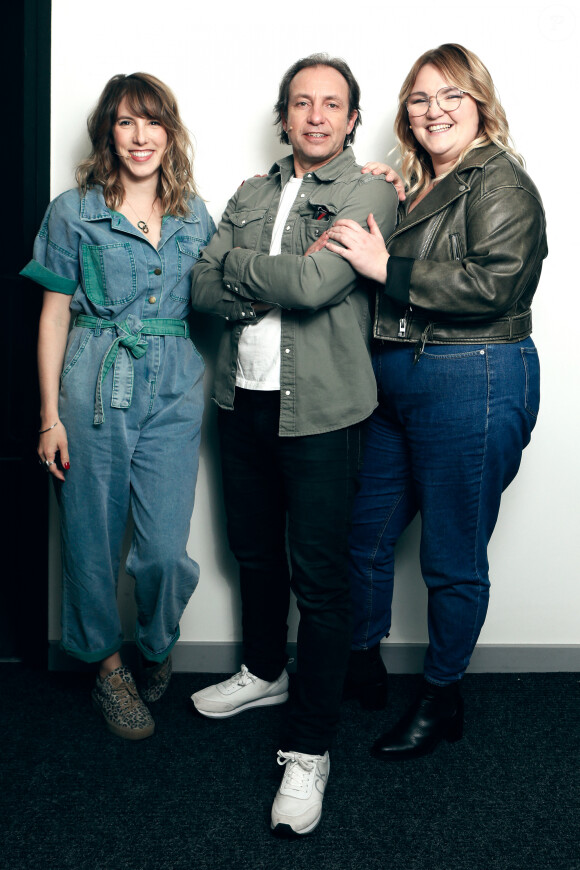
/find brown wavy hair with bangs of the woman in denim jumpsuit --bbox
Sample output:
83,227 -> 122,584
75,72 -> 197,217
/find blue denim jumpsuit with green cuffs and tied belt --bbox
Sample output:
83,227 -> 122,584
22,188 -> 215,662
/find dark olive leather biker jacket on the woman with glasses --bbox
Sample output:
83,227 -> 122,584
374,145 -> 548,352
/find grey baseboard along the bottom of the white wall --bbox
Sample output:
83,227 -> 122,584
48,641 -> 580,674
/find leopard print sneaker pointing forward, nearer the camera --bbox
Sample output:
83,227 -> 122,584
92,667 -> 155,740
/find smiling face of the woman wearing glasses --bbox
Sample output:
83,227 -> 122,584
409,64 -> 480,175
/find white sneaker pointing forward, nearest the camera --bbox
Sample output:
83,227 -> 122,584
271,750 -> 330,834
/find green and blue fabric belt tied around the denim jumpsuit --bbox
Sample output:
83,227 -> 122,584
73,314 -> 189,425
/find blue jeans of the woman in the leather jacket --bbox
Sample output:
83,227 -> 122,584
350,338 -> 540,685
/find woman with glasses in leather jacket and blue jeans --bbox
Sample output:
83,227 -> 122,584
326,44 -> 547,760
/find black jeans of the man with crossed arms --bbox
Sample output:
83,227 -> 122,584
219,389 -> 362,755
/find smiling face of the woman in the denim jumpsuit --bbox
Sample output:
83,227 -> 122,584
112,99 -> 167,183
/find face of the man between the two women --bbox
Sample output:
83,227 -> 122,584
283,66 -> 357,178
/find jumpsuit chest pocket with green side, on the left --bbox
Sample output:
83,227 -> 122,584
82,242 -> 137,305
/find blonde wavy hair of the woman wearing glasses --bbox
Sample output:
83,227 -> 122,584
395,43 -> 524,194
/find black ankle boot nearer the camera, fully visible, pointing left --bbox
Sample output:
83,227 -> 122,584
371,680 -> 463,761
